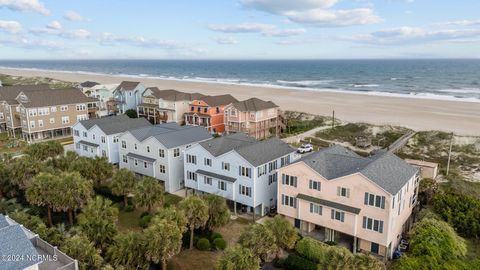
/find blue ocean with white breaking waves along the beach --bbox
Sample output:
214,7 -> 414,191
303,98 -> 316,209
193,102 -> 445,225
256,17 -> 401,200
0,59 -> 480,102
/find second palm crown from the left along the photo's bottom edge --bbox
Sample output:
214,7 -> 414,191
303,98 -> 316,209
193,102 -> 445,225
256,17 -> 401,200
107,232 -> 149,270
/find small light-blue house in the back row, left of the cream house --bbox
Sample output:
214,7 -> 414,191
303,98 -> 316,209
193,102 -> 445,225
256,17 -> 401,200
113,81 -> 145,114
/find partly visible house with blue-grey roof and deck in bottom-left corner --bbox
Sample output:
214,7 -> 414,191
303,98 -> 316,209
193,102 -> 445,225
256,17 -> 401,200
0,214 -> 79,270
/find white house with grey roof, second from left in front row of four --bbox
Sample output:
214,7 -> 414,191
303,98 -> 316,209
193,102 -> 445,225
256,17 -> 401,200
119,123 -> 211,193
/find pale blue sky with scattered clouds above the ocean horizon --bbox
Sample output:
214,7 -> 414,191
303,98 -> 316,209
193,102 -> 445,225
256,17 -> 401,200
0,0 -> 480,59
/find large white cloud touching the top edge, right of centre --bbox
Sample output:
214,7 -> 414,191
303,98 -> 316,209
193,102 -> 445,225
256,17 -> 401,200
240,0 -> 382,27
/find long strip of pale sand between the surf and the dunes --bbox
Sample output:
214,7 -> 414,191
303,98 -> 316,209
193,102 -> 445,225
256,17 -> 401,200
0,69 -> 480,136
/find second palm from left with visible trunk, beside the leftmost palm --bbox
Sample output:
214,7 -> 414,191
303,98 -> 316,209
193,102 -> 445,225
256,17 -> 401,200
57,172 -> 93,225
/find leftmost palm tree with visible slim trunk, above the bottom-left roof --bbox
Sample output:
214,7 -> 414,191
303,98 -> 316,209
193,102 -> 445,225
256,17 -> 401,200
25,173 -> 59,227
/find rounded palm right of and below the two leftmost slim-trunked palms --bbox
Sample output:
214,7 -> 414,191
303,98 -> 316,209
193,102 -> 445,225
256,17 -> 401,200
78,196 -> 118,249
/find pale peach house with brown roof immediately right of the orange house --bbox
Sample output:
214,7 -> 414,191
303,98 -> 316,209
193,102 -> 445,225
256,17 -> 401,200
225,98 -> 280,140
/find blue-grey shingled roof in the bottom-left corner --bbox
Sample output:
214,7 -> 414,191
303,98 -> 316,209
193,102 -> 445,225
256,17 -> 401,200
0,225 -> 41,270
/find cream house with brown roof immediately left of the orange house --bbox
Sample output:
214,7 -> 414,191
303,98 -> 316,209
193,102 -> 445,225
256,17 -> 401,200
137,87 -> 203,124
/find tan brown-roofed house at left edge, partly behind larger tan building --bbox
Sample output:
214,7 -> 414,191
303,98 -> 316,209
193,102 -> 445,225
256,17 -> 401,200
0,84 -> 50,137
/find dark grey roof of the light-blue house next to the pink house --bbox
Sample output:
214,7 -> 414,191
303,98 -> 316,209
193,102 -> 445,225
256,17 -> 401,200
200,133 -> 295,166
